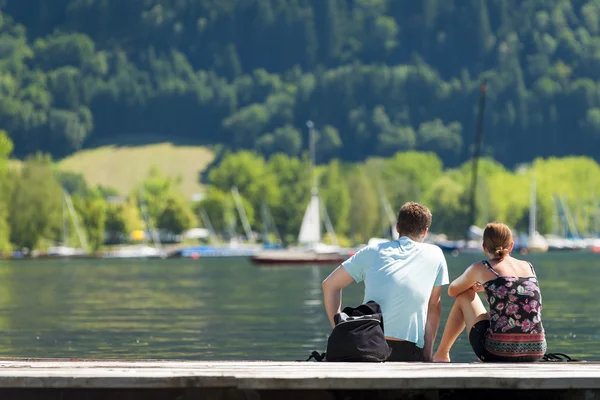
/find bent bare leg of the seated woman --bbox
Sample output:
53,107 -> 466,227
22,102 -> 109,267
433,289 -> 489,362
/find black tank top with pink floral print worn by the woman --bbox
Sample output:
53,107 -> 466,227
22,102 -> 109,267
483,261 -> 546,358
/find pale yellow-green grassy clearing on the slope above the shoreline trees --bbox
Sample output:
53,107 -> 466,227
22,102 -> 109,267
58,143 -> 214,198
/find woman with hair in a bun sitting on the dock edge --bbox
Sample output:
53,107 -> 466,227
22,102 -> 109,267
433,222 -> 546,362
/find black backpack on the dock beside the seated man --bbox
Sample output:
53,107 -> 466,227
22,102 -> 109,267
307,301 -> 392,362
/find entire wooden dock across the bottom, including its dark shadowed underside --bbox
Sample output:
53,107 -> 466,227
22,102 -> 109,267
0,360 -> 600,400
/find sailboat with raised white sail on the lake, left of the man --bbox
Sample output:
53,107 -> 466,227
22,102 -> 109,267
251,121 -> 349,264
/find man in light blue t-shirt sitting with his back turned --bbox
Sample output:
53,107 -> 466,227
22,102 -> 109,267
323,202 -> 448,361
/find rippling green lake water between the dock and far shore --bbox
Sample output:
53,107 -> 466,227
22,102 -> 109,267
0,253 -> 600,362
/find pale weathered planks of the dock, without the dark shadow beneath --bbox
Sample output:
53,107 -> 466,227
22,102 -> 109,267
0,360 -> 600,390
